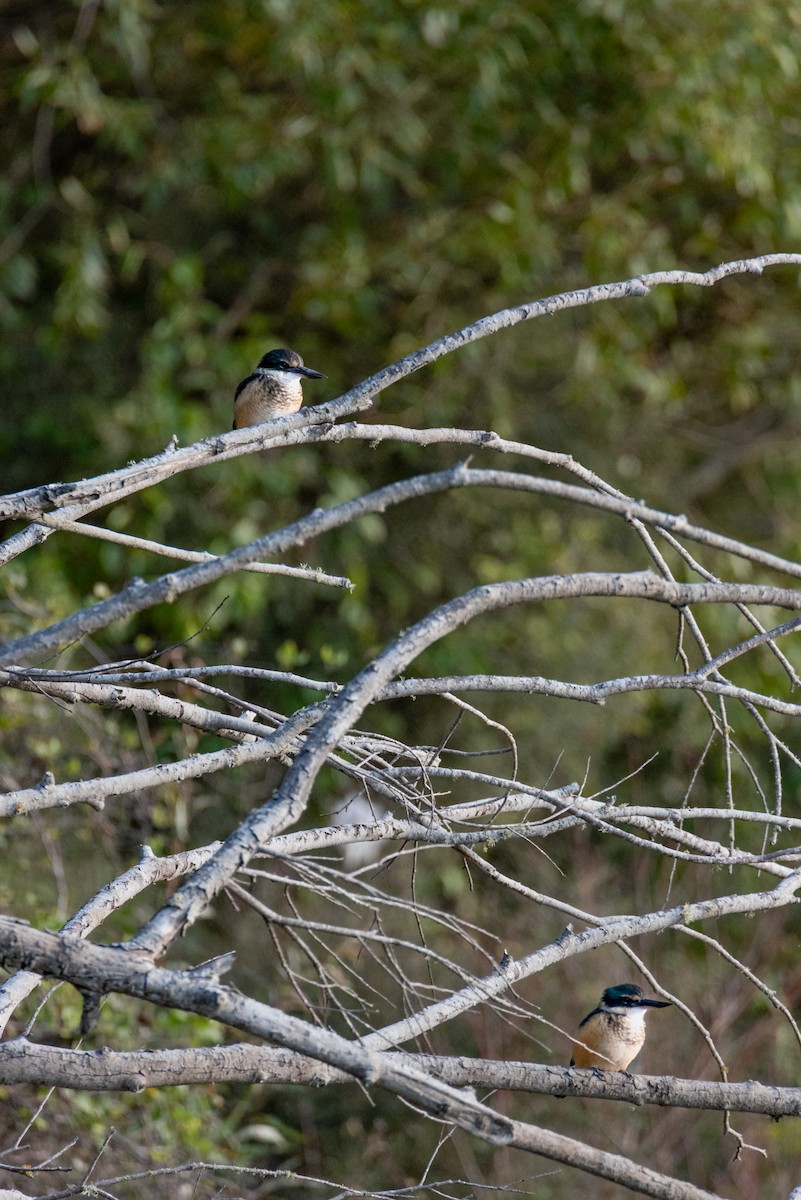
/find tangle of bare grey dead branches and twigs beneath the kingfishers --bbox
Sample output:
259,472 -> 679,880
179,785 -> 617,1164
0,254 -> 801,1200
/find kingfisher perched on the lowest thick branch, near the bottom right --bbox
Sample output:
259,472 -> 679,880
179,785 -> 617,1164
570,983 -> 670,1070
